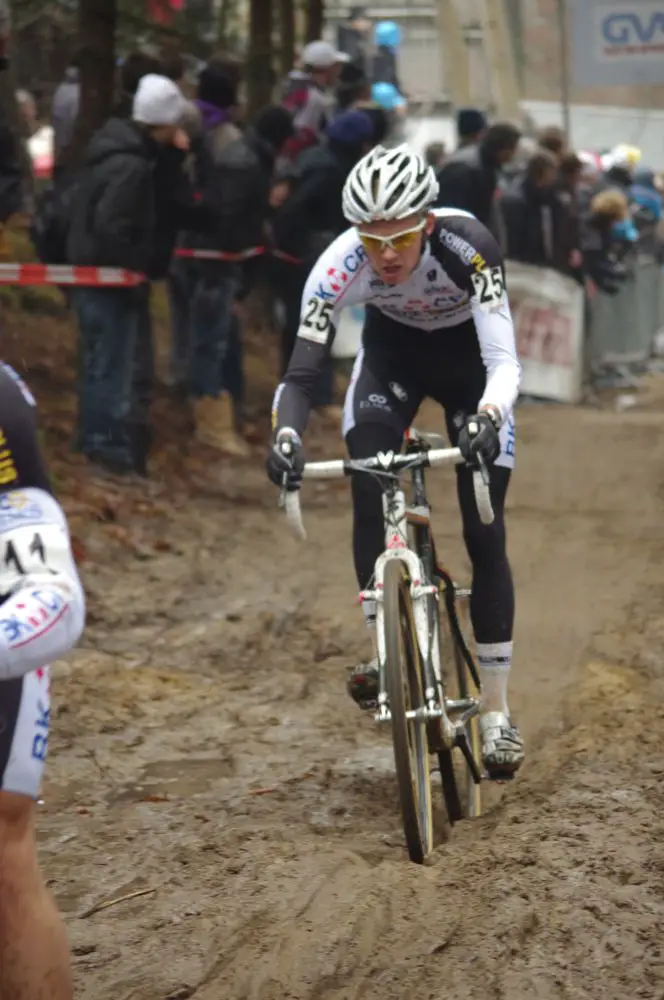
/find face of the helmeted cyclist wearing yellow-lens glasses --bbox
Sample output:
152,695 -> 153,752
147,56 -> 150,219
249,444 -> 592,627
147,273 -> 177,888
357,214 -> 435,285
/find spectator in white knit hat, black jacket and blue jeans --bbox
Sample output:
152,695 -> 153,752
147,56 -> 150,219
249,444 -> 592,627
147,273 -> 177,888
67,74 -> 214,475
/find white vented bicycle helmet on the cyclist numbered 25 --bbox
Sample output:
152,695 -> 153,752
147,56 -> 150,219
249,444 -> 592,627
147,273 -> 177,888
343,143 -> 438,225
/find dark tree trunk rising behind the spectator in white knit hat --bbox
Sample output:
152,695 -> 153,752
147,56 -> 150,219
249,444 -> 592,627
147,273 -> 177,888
66,0 -> 118,166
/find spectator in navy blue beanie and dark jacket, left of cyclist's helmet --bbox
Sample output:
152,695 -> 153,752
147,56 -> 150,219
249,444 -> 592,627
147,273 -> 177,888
273,111 -> 375,416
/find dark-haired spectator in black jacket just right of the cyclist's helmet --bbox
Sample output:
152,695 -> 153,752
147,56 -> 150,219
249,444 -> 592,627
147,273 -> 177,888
436,122 -> 521,230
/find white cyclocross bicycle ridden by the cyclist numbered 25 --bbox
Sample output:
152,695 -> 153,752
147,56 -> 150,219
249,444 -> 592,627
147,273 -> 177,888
280,429 -> 493,864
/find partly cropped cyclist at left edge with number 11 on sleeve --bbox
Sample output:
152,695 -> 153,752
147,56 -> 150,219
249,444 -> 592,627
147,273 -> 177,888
0,363 -> 85,1000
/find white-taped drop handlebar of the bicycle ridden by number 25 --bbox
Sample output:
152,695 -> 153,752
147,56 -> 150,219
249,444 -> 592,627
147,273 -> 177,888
280,448 -> 494,539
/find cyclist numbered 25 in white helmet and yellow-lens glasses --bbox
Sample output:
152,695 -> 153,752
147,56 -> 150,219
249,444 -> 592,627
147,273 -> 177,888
267,145 -> 524,777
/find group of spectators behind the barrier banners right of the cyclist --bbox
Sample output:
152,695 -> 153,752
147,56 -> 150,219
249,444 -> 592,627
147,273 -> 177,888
428,108 -> 664,295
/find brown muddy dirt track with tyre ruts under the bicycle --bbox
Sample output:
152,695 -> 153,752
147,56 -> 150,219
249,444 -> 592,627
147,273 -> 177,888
14,322 -> 664,1000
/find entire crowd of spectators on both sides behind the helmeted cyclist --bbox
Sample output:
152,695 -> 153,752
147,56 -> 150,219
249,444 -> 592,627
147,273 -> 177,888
0,7 -> 662,476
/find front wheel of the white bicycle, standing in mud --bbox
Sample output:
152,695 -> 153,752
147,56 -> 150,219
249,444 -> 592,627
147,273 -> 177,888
383,559 -> 433,864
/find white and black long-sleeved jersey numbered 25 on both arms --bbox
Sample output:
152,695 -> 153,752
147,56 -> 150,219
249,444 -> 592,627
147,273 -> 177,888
273,209 -> 520,433
